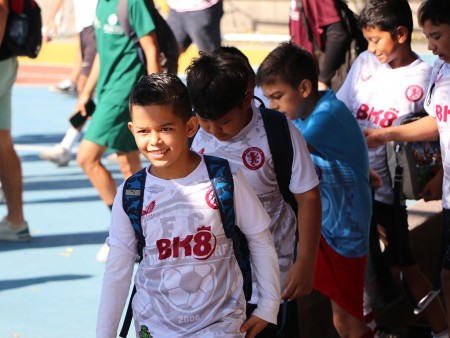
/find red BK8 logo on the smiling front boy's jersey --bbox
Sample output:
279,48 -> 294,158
156,226 -> 217,261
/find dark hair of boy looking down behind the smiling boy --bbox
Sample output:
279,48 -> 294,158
186,52 -> 252,120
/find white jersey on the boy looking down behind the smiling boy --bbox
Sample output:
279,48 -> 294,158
192,103 -> 319,303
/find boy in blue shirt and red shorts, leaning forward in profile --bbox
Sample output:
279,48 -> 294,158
256,42 -> 373,338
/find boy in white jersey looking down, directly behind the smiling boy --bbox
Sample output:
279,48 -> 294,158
187,51 -> 321,338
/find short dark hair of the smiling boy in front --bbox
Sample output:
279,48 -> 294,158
129,73 -> 192,121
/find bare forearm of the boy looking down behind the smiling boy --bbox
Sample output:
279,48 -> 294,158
281,186 -> 322,299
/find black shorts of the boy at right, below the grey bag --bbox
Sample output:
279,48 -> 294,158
373,201 -> 416,267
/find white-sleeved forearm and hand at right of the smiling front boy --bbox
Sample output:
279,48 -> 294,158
241,229 -> 280,338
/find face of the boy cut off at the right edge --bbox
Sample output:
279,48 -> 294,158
422,20 -> 450,63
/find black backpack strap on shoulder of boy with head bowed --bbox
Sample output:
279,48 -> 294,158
259,108 -> 297,214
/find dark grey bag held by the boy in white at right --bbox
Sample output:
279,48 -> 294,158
386,112 -> 442,203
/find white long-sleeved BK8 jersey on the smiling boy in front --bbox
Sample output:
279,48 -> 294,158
97,161 -> 280,338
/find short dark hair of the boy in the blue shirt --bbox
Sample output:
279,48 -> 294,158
256,42 -> 318,89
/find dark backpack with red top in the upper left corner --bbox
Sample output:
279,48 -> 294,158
4,0 -> 42,59
